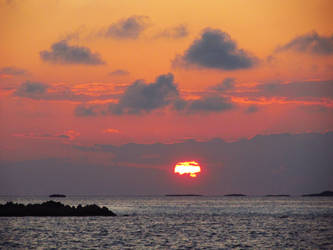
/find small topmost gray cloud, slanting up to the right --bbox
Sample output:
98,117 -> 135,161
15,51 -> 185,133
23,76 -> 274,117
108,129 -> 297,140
102,16 -> 149,39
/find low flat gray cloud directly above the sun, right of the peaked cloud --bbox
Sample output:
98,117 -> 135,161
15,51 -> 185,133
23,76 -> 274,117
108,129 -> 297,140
186,96 -> 234,113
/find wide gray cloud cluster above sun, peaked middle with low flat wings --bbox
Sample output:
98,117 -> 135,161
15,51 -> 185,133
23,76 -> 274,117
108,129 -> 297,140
75,73 -> 234,116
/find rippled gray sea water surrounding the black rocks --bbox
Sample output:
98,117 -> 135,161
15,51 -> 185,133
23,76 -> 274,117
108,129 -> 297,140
0,196 -> 333,249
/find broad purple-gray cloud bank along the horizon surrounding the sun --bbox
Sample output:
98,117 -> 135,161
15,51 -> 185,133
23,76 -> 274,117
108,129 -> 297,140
0,132 -> 333,195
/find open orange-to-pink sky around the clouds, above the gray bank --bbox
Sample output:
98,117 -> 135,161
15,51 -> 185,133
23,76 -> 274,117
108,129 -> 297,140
0,0 -> 333,152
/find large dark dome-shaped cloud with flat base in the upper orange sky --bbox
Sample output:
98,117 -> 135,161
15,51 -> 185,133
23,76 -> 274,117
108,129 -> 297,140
173,28 -> 258,70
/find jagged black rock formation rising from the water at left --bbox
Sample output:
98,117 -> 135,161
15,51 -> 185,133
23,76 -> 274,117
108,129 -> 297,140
0,201 -> 116,216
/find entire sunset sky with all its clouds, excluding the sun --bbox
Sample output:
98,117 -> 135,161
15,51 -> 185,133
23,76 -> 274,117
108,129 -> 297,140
0,0 -> 333,195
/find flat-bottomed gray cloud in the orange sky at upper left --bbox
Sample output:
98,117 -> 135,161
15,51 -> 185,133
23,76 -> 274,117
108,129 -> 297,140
39,40 -> 105,65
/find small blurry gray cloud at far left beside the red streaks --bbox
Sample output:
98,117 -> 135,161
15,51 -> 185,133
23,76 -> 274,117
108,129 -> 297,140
14,81 -> 49,99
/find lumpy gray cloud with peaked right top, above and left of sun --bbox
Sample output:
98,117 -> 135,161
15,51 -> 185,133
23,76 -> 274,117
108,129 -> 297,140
109,73 -> 179,114
